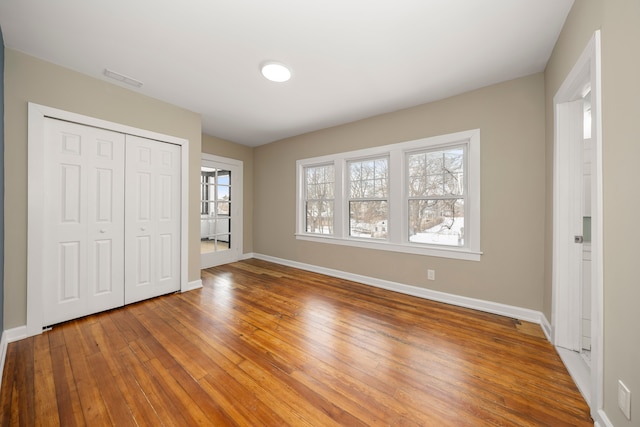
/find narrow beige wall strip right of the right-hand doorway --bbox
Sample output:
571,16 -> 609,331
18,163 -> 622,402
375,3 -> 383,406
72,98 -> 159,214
602,0 -> 640,427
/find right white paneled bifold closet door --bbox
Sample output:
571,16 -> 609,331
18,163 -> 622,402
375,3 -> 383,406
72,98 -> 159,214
125,135 -> 181,304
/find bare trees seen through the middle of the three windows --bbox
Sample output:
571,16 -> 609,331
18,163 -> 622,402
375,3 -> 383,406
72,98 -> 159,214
349,157 -> 389,239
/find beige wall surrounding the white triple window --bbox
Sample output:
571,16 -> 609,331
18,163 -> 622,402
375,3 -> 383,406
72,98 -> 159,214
254,74 -> 545,310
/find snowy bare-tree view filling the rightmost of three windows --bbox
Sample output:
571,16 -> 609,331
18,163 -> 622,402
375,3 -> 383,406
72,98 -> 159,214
407,146 -> 466,246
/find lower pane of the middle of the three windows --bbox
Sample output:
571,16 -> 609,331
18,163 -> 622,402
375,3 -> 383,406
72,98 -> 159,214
349,200 -> 389,239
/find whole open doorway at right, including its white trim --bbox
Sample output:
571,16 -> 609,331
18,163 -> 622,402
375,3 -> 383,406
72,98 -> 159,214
551,31 -> 603,420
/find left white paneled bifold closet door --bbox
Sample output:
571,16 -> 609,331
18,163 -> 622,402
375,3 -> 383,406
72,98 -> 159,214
42,119 -> 125,325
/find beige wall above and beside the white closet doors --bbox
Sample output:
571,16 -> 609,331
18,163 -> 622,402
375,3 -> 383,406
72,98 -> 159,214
4,49 -> 202,329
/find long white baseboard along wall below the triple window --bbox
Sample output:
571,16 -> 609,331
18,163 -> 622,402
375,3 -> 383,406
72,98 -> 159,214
253,253 -> 551,339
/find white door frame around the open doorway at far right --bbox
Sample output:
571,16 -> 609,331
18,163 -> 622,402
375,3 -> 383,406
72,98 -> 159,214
551,30 -> 604,421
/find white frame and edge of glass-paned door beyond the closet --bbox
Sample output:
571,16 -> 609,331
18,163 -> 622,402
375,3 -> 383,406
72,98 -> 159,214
200,153 -> 244,269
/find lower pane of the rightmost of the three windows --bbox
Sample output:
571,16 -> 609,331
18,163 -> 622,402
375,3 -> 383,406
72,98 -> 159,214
409,199 -> 464,246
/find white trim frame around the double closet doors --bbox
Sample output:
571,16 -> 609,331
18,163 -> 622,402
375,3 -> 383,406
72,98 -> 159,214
26,102 -> 189,336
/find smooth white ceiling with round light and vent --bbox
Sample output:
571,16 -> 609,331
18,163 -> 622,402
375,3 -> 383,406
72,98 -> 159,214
0,0 -> 573,146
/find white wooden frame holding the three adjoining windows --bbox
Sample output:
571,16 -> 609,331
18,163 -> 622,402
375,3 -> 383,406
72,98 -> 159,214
296,129 -> 482,261
